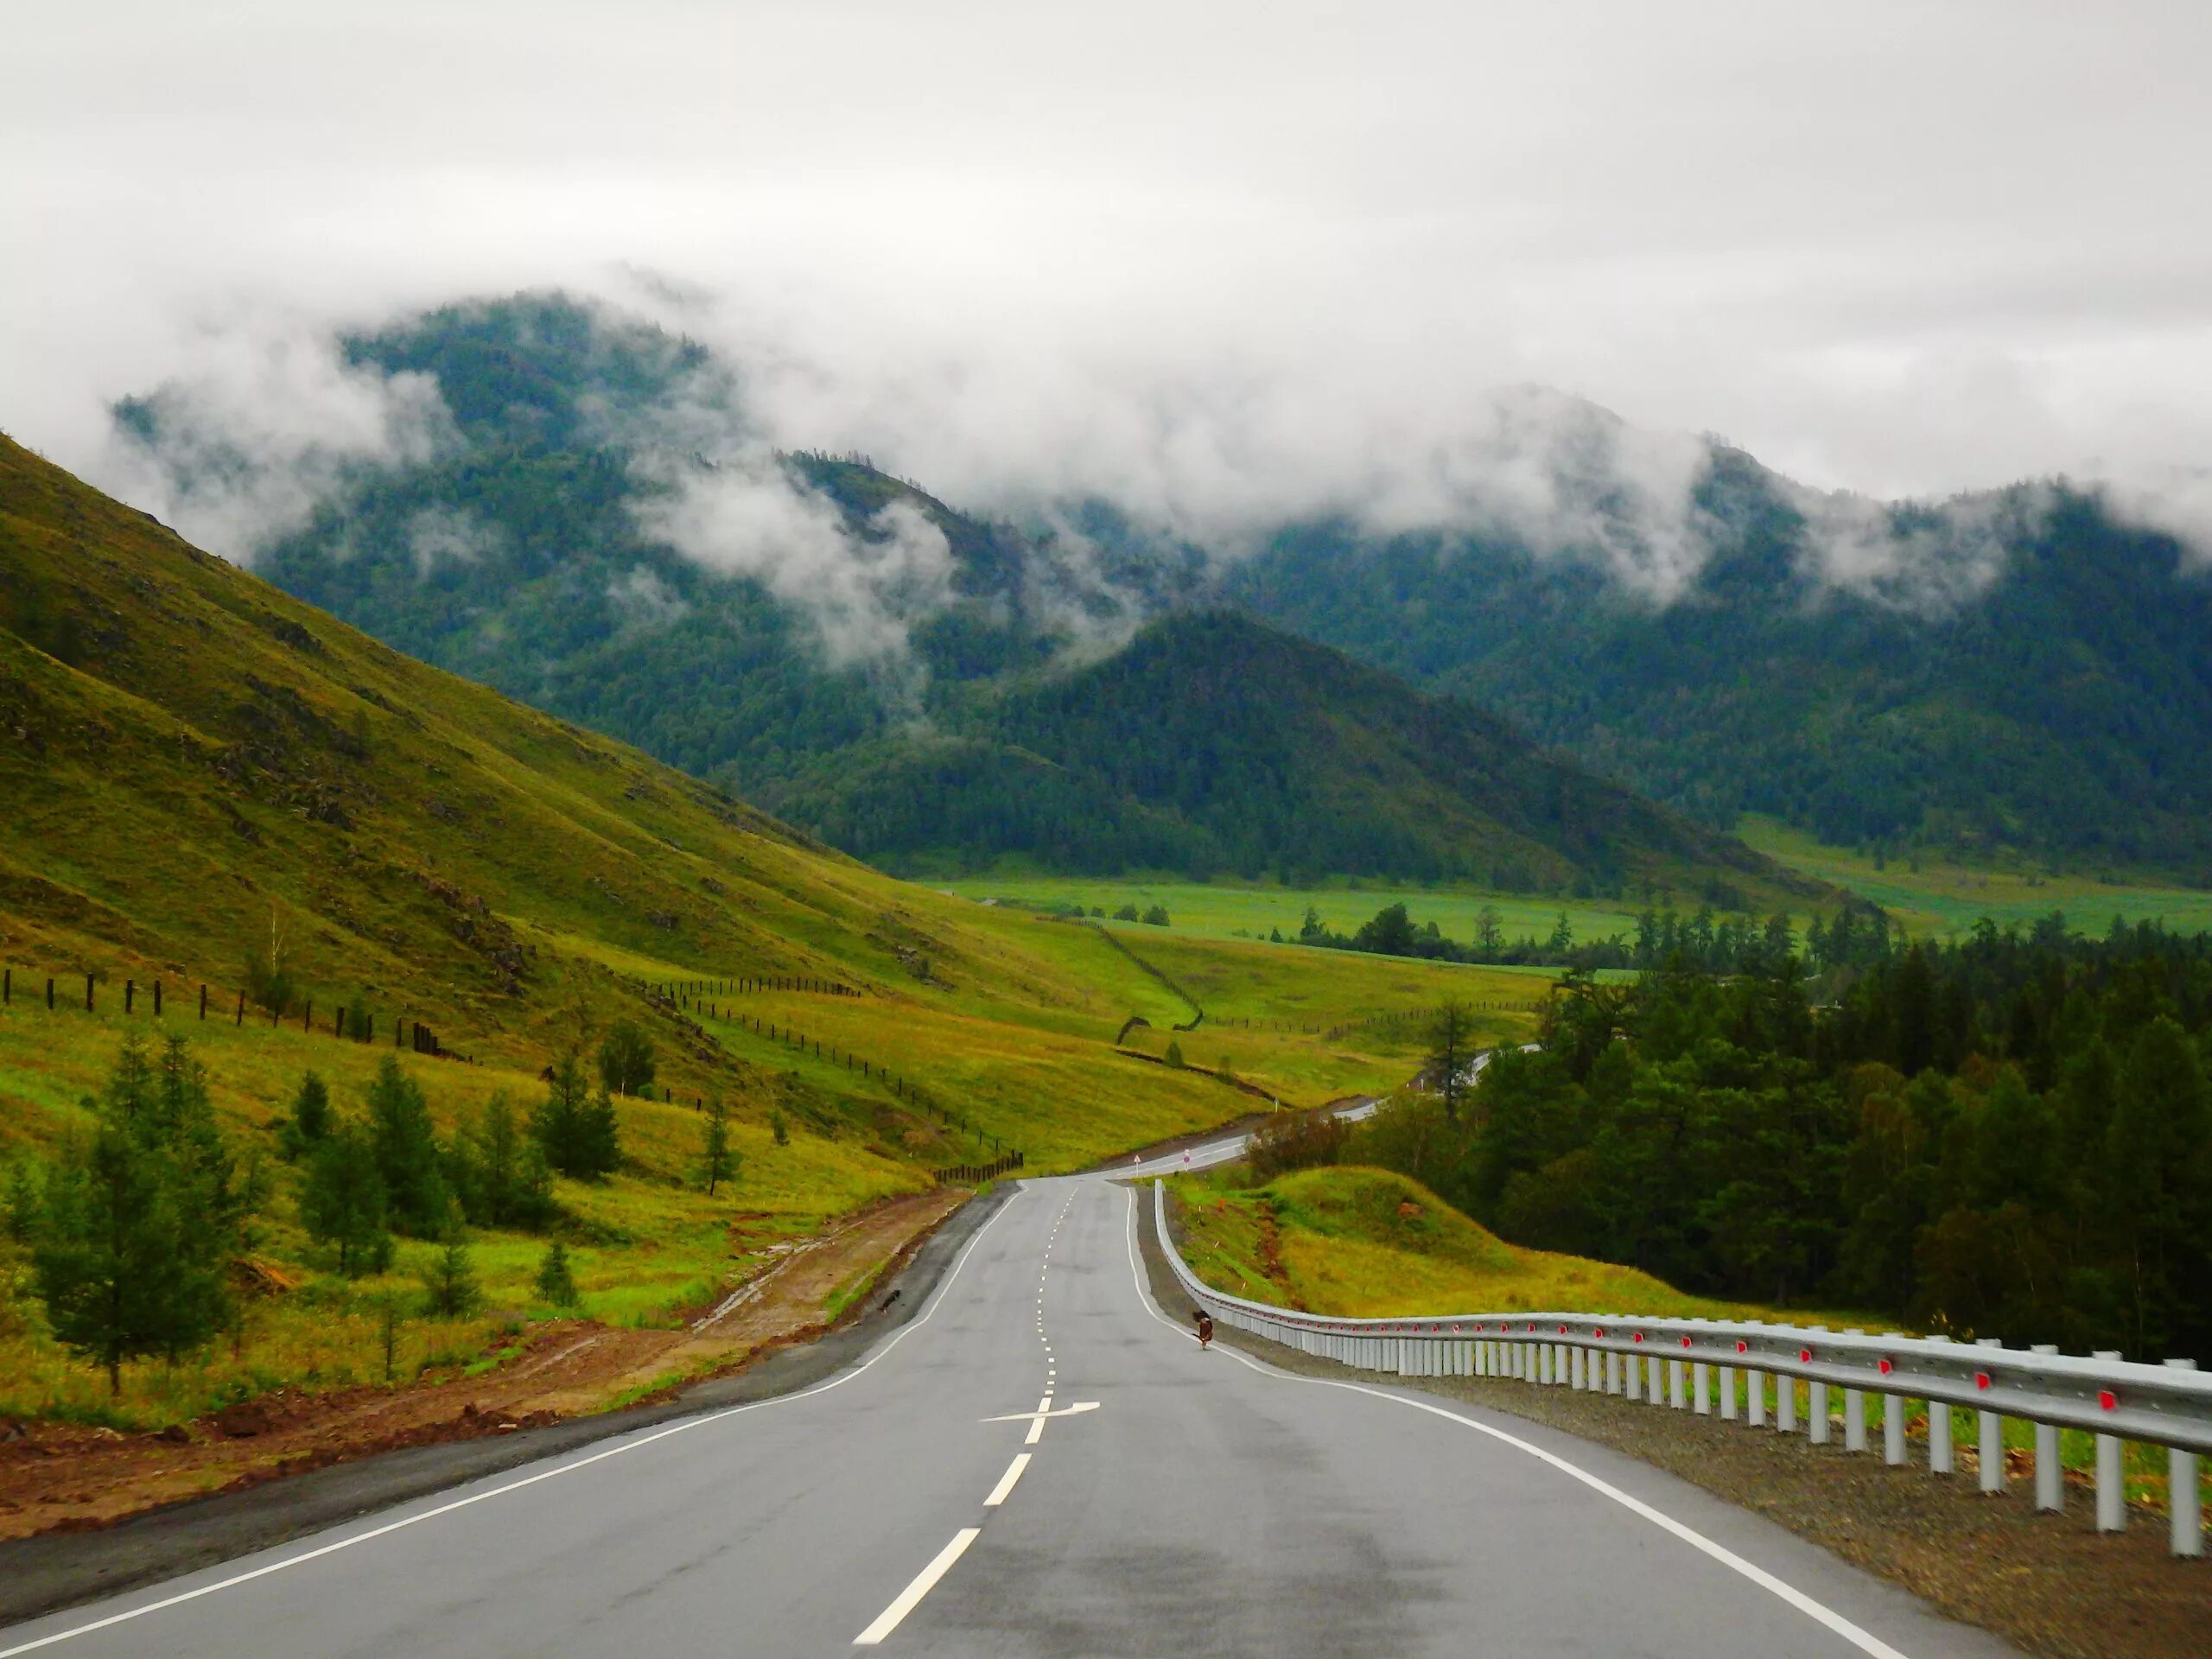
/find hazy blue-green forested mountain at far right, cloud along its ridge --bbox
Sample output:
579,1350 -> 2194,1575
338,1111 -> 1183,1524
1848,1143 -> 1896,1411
1228,449 -> 2212,882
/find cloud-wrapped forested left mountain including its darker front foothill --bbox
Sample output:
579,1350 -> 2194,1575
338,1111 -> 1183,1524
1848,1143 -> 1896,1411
104,296 -> 1814,907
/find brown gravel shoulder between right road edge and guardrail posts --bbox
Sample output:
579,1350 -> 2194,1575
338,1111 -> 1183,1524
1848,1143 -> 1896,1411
1137,1192 -> 2212,1659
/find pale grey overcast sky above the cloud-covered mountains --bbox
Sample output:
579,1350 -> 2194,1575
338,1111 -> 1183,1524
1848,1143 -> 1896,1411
0,0 -> 2212,519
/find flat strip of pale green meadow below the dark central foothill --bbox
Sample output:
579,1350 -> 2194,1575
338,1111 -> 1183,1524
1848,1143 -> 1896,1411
936,869 -> 1637,973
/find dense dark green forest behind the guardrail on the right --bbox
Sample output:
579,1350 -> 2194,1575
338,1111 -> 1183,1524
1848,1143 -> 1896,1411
1340,918 -> 2212,1360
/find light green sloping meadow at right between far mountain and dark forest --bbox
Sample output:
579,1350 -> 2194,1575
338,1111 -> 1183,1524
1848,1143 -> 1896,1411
1737,817 -> 2212,938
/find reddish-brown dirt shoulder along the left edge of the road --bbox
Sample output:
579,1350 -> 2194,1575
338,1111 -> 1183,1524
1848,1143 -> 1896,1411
0,1188 -> 998,1624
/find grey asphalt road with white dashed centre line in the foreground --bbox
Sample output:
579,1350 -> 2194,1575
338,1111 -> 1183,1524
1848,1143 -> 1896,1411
0,1177 -> 2008,1659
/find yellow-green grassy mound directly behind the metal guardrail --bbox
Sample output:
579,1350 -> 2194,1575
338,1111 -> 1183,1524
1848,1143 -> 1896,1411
1168,1166 -> 2165,1506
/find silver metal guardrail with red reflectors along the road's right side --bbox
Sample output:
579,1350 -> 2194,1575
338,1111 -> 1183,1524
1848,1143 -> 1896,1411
1153,1179 -> 2212,1555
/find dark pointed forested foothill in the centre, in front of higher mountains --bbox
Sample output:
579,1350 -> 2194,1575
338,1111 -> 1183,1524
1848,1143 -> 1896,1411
772,613 -> 1818,907
